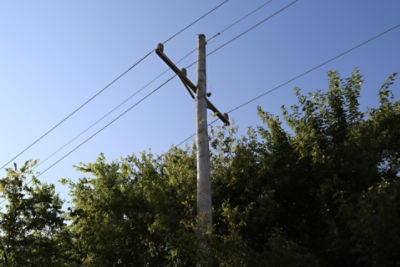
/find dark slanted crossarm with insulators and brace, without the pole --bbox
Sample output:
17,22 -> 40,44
156,43 -> 229,125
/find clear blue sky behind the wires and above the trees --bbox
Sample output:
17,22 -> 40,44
0,0 -> 400,201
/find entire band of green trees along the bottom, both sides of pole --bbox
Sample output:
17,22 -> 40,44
0,69 -> 400,266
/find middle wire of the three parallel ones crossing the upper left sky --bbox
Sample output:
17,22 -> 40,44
34,0 -> 272,171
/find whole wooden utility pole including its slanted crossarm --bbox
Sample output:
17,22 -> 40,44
156,34 -> 229,266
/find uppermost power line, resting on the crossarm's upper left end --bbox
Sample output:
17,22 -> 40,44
0,0 -> 229,169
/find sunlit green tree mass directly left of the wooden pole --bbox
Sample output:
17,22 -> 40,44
70,152 -> 202,266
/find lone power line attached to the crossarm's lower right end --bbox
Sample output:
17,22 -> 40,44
176,24 -> 400,147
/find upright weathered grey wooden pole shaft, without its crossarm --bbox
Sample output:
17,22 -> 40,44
196,34 -> 212,264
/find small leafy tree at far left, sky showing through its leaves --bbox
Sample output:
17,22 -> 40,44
0,162 -> 71,266
